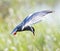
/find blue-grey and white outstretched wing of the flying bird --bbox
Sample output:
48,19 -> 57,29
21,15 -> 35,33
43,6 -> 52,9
21,10 -> 53,27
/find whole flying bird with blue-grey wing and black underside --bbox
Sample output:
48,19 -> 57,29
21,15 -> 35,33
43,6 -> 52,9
11,10 -> 53,35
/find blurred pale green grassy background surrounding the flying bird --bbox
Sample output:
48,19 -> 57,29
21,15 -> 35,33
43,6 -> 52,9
0,0 -> 60,51
